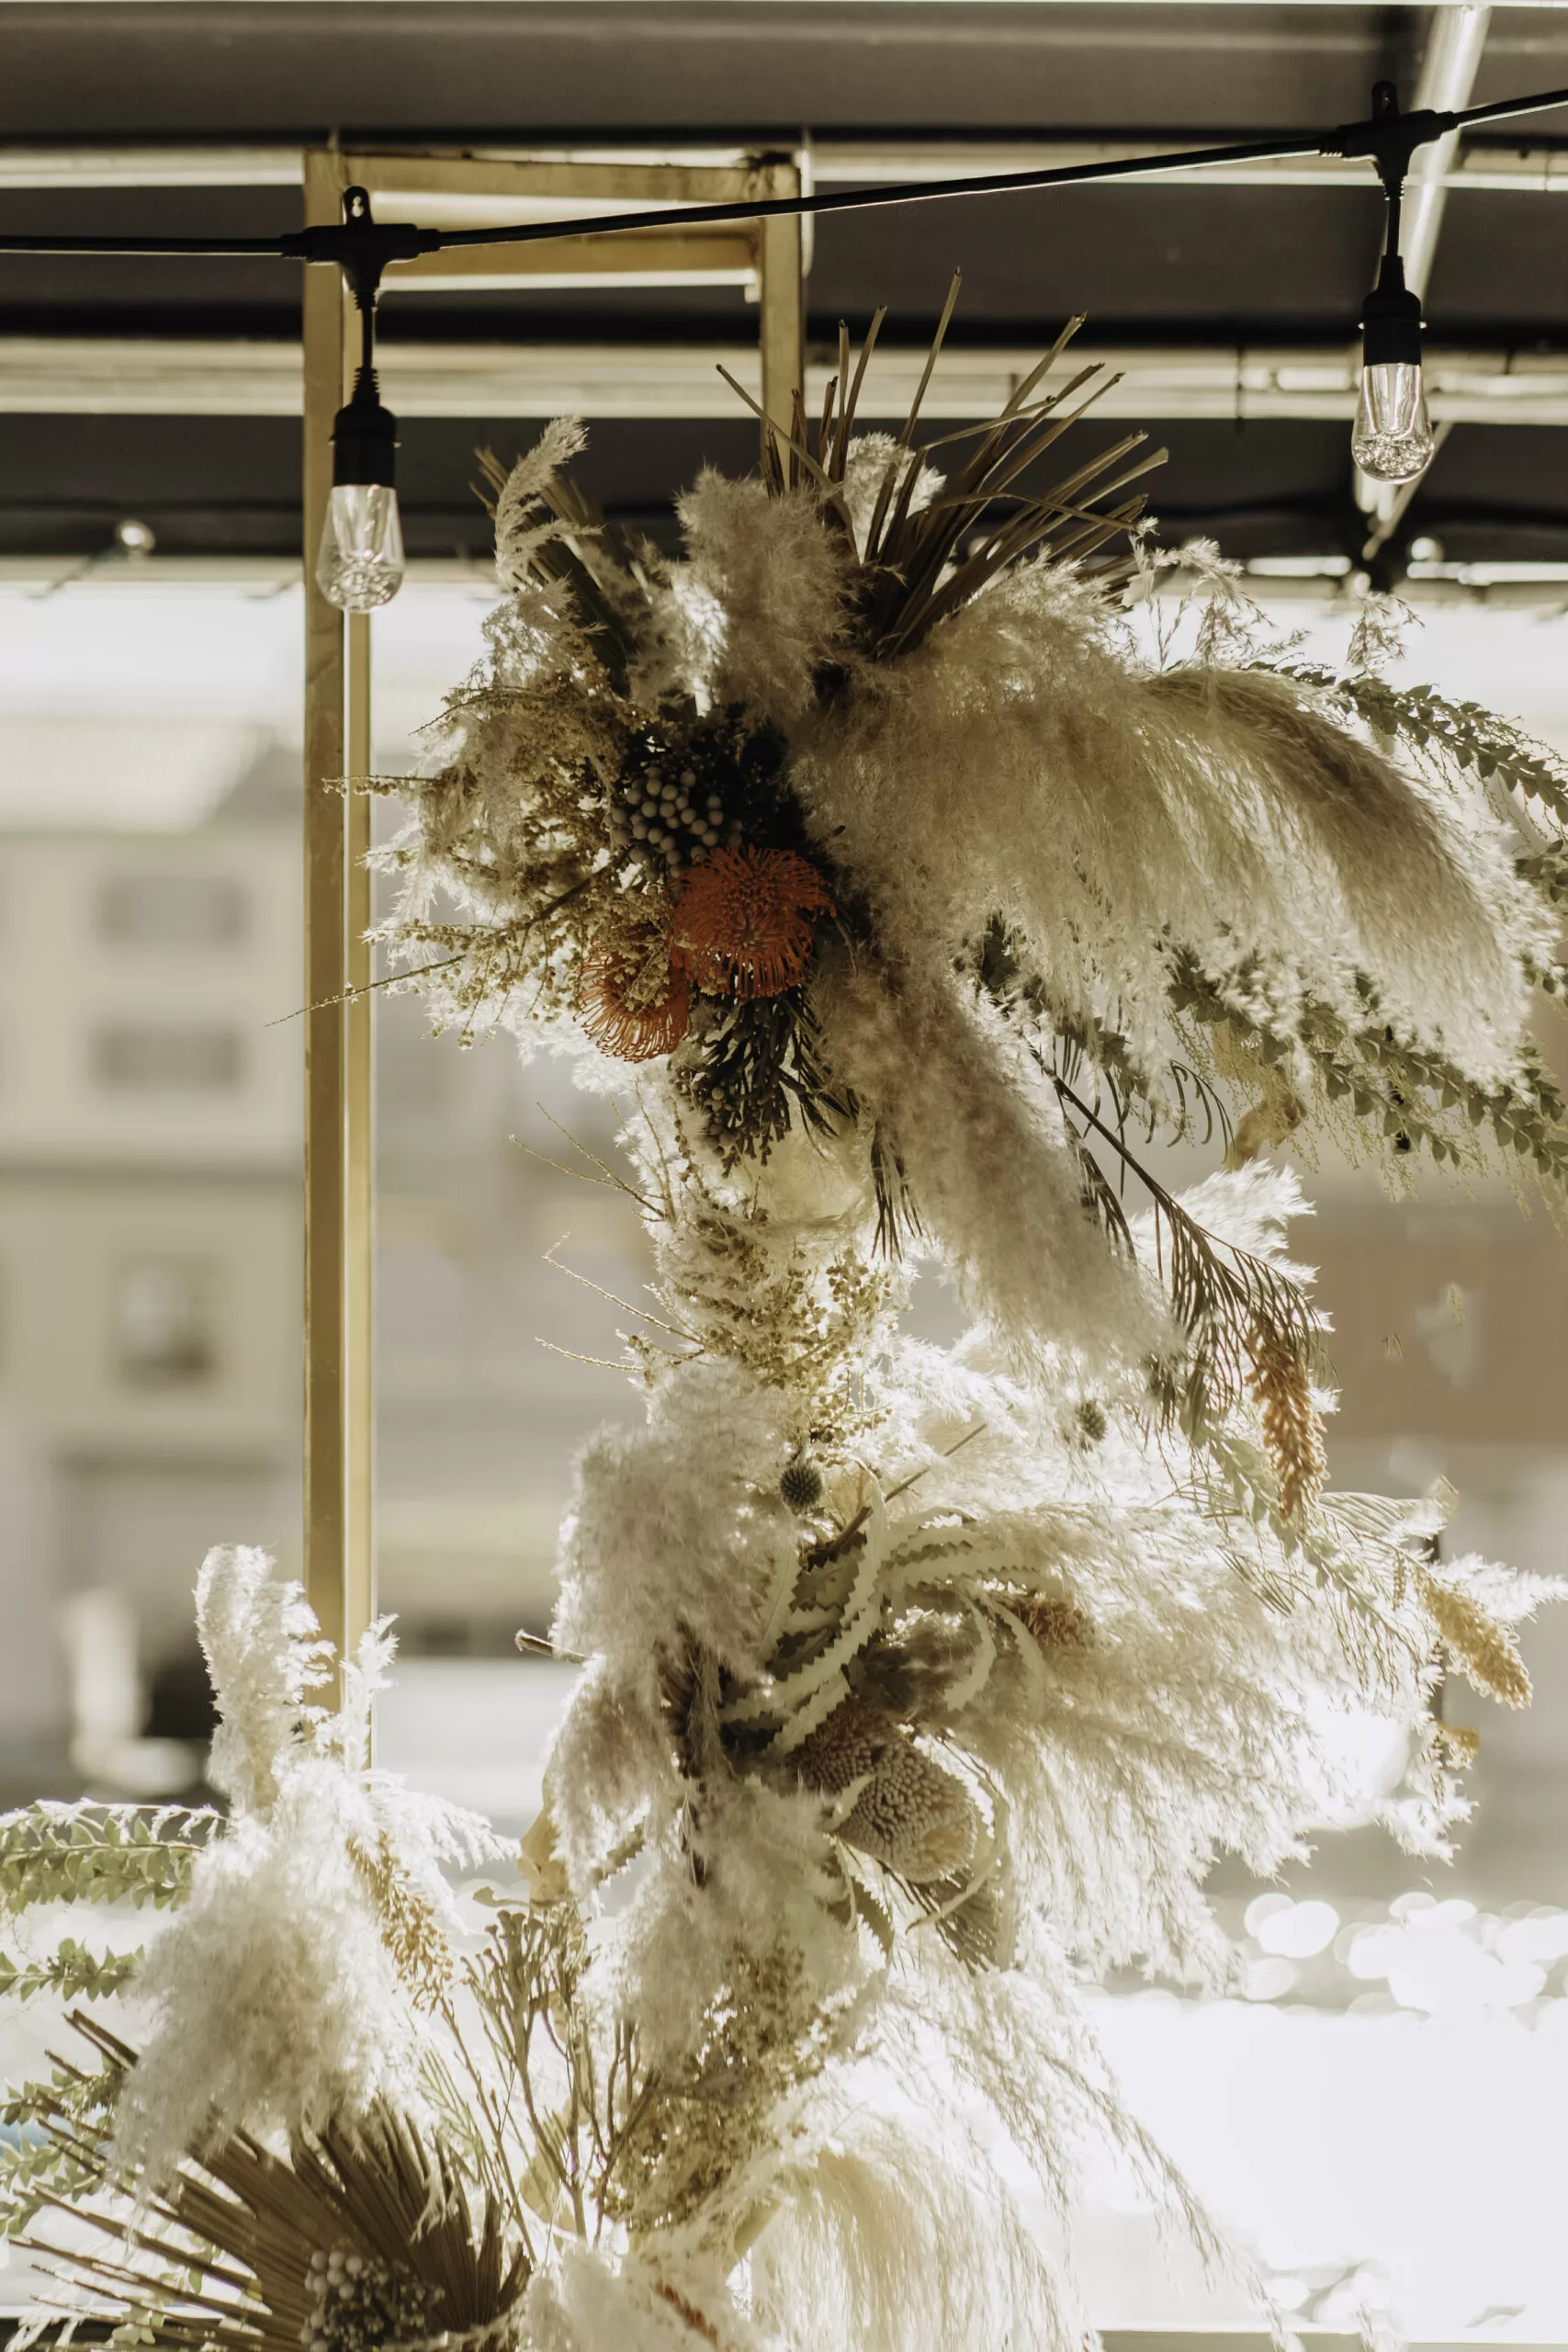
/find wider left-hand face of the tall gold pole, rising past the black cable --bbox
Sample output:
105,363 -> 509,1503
303,153 -> 348,1674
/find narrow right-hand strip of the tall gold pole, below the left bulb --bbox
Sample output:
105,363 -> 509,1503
344,612 -> 376,1649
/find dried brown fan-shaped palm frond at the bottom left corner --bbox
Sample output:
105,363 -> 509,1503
24,2011 -> 531,2352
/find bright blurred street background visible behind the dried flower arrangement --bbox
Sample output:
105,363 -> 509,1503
0,570 -> 1568,2343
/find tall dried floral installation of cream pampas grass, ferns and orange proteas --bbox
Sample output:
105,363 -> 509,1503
0,303 -> 1568,2352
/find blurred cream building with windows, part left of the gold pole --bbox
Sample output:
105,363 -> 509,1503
0,710 -> 301,1771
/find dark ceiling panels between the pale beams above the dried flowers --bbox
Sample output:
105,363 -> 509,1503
0,0 -> 1568,560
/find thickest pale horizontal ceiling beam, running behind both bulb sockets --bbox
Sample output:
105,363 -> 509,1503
0,336 -> 1568,425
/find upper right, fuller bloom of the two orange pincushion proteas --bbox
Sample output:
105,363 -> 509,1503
670,847 -> 832,997
